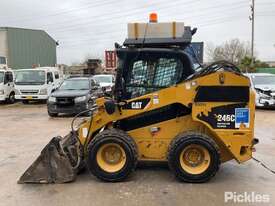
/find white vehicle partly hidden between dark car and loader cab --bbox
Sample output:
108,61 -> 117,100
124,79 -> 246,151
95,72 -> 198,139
93,74 -> 115,94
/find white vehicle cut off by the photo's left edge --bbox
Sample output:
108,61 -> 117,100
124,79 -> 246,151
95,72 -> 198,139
0,69 -> 15,104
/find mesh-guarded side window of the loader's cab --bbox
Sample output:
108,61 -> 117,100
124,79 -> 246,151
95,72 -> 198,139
126,57 -> 183,98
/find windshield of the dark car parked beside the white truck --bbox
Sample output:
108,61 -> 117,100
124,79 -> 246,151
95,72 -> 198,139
59,79 -> 90,90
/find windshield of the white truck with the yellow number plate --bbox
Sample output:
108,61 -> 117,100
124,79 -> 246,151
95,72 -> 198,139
15,70 -> 46,85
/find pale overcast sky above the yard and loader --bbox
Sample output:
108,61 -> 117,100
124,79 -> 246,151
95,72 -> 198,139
0,0 -> 275,64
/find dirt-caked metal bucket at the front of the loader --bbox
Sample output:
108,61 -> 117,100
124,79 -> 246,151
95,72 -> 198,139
18,134 -> 78,184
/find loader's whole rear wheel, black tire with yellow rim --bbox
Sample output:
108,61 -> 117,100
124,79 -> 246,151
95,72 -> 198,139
168,132 -> 220,183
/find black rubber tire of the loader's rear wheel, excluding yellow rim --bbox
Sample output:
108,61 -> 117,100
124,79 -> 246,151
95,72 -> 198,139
167,132 -> 220,183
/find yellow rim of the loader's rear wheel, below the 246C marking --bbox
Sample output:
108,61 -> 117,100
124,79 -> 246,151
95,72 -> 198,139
180,144 -> 211,175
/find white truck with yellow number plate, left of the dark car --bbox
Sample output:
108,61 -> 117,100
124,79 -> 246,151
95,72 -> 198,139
14,67 -> 63,104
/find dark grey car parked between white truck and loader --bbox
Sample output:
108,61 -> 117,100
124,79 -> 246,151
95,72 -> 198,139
47,77 -> 102,117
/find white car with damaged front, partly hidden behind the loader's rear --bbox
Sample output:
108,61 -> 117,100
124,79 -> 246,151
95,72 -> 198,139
247,73 -> 275,108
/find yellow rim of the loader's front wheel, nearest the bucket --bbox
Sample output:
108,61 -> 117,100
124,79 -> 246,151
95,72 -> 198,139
96,143 -> 126,173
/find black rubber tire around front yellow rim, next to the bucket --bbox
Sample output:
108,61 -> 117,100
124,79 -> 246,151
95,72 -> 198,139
86,129 -> 138,182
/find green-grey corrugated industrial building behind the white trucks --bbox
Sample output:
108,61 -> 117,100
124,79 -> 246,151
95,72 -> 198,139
0,27 -> 57,69
